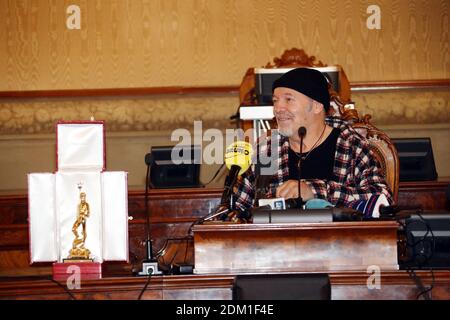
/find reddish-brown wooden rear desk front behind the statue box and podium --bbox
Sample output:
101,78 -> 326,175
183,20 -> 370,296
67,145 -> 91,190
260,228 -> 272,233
0,178 -> 450,275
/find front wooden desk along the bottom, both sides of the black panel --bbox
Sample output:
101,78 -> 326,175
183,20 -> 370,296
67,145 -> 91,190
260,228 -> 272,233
0,271 -> 450,300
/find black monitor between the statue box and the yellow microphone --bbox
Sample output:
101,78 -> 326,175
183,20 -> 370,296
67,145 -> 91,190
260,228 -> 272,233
150,145 -> 202,188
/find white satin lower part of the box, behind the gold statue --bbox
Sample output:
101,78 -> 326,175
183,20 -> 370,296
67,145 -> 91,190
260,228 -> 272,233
28,172 -> 128,263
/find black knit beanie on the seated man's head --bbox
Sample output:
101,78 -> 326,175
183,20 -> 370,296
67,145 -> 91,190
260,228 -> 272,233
272,68 -> 330,113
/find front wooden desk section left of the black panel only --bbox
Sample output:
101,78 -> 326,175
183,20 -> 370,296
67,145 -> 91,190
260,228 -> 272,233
0,276 -> 234,300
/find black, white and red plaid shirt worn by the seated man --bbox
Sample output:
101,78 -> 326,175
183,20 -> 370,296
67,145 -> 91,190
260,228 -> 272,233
234,117 -> 393,210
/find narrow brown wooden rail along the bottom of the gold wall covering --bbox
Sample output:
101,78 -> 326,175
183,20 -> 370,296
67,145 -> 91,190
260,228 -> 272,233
0,79 -> 450,99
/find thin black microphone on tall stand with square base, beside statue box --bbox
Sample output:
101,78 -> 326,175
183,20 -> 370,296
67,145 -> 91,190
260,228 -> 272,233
139,154 -> 162,276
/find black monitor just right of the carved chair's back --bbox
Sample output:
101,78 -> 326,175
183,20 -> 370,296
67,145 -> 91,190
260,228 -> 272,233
392,138 -> 437,181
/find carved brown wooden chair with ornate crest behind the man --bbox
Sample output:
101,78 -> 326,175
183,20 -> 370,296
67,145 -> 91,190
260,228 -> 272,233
239,48 -> 399,202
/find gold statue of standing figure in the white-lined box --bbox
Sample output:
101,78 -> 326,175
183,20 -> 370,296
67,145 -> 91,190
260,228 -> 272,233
68,187 -> 91,261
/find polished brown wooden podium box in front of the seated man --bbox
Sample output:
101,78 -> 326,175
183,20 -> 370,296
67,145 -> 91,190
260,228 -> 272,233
193,221 -> 399,274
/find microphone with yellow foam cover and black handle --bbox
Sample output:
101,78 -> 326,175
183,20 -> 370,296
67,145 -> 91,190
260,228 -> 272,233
220,141 -> 253,210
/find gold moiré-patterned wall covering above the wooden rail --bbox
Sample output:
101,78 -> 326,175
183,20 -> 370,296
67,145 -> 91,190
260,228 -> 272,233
0,0 -> 450,91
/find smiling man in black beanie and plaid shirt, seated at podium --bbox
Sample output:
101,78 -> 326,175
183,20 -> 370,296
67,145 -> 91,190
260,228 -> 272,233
230,68 -> 392,210
